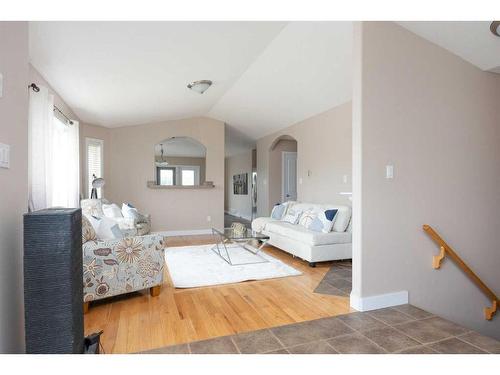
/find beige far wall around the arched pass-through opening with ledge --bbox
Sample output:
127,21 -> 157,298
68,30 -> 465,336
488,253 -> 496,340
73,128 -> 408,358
104,117 -> 224,231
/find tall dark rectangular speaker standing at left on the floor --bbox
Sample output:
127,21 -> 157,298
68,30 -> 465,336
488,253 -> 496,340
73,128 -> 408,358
24,208 -> 83,353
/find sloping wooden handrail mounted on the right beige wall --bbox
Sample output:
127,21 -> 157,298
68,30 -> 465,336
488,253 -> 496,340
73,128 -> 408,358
423,224 -> 500,320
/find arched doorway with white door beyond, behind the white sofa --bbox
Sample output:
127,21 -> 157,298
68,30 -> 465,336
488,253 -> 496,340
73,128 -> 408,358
269,135 -> 298,213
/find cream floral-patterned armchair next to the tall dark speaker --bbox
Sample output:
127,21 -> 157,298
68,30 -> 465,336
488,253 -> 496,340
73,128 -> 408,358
82,218 -> 165,312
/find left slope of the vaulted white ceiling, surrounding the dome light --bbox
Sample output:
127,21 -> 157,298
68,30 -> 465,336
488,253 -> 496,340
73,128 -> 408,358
30,22 -> 286,127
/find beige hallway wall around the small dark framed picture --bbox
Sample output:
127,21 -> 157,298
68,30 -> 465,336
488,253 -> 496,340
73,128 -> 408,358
224,150 -> 252,220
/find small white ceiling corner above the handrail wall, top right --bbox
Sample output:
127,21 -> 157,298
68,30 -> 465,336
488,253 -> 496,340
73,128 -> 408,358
398,21 -> 500,73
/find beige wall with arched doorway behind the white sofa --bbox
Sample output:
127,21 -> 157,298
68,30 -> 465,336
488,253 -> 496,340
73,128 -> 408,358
257,102 -> 352,216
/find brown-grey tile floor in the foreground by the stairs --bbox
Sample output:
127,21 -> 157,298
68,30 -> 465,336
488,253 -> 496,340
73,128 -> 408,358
144,305 -> 500,354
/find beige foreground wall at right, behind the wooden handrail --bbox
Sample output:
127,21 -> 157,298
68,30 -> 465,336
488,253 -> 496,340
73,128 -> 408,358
353,22 -> 500,339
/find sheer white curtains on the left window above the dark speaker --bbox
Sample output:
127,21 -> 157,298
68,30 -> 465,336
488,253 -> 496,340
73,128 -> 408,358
28,86 -> 80,211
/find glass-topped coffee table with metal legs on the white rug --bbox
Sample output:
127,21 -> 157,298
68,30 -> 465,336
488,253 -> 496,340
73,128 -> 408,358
212,228 -> 269,266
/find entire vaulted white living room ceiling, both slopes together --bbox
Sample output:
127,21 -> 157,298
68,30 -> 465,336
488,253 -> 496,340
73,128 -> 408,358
30,22 -> 352,147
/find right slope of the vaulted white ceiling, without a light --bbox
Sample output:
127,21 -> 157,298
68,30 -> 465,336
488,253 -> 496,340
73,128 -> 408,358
209,22 -> 353,138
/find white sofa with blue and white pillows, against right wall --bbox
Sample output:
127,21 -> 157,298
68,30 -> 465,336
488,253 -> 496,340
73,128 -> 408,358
252,202 -> 352,267
